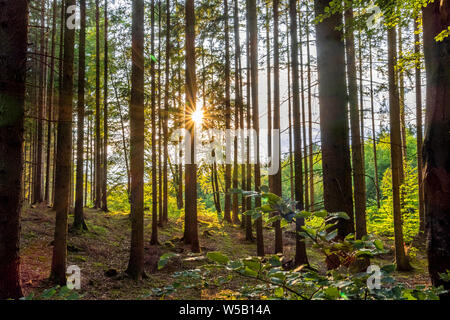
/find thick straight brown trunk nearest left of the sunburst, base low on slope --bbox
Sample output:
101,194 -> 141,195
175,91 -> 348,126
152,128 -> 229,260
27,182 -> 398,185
126,0 -> 145,280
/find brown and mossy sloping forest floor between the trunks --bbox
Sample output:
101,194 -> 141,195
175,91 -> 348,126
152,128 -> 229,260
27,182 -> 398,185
21,207 -> 430,300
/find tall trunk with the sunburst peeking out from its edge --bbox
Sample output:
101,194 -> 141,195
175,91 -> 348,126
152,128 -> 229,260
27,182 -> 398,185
184,0 -> 200,252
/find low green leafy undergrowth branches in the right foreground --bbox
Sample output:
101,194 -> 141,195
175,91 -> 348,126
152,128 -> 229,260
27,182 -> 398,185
156,192 -> 444,300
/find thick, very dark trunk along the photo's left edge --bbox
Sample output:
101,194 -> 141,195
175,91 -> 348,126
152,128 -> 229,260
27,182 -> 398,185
0,0 -> 28,300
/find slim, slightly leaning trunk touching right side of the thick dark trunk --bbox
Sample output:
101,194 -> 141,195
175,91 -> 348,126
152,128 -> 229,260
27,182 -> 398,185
345,8 -> 367,239
